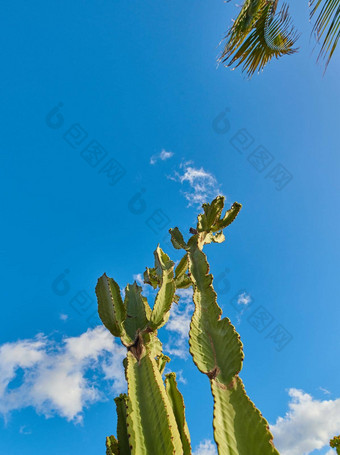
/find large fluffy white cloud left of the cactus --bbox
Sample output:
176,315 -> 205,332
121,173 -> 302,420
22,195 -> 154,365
0,327 -> 125,422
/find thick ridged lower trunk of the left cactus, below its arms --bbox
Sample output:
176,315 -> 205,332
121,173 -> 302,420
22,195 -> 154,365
127,352 -> 183,455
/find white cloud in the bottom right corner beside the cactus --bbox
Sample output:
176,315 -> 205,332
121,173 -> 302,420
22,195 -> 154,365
271,389 -> 340,455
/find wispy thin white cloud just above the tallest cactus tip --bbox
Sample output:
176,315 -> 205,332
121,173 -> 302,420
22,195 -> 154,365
169,161 -> 222,208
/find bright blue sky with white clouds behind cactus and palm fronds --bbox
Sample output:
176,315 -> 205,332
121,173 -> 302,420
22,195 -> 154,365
0,0 -> 340,455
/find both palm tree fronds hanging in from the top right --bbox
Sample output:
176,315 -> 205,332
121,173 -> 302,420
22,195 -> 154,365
220,0 -> 340,77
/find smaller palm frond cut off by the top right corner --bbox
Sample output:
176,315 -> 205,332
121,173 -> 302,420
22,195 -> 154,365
311,0 -> 340,68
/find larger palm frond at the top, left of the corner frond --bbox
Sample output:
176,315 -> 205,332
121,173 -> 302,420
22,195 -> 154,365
220,0 -> 298,77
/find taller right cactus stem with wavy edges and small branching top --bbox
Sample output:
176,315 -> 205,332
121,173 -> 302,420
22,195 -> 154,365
170,197 -> 278,455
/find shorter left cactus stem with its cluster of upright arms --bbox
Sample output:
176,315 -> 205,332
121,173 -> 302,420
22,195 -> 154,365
96,247 -> 191,455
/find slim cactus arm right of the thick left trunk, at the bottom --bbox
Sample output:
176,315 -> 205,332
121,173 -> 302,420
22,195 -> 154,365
165,373 -> 191,455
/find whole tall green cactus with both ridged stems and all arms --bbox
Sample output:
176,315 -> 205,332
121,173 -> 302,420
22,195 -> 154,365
96,196 -> 279,455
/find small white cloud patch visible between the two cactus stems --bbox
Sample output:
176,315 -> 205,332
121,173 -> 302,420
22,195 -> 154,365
164,288 -> 194,359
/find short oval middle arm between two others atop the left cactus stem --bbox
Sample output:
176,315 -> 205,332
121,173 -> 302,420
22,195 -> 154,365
124,282 -> 151,340
